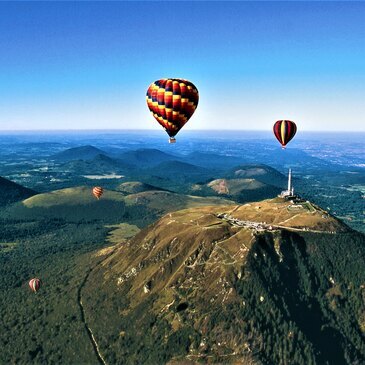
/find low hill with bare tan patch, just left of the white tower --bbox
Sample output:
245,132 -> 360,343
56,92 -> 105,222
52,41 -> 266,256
191,179 -> 281,203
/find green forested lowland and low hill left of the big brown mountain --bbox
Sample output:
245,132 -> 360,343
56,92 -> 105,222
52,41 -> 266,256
0,187 -> 235,364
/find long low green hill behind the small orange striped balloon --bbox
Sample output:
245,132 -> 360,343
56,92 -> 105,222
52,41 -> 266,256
3,186 -> 232,226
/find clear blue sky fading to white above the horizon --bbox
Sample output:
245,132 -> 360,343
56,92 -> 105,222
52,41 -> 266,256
0,1 -> 365,131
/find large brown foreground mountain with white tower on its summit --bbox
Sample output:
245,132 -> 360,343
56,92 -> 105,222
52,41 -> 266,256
82,198 -> 365,365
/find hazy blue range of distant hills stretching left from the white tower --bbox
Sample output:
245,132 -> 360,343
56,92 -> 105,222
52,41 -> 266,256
53,146 -> 286,187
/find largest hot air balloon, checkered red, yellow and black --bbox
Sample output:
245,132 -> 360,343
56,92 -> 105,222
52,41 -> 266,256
146,79 -> 199,143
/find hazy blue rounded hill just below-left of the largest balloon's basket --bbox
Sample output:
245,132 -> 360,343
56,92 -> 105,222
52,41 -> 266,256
119,148 -> 178,168
